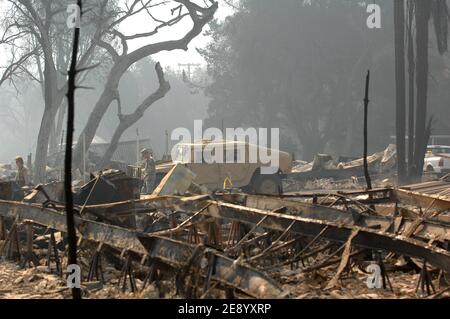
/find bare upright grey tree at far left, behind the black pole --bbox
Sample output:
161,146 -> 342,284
0,0 -> 115,183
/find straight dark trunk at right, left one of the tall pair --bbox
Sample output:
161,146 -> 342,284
394,0 -> 406,185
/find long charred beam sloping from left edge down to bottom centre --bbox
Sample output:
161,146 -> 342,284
0,200 -> 282,298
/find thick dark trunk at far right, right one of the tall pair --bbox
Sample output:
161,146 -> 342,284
414,0 -> 431,178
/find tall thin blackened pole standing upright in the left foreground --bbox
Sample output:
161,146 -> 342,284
64,0 -> 82,299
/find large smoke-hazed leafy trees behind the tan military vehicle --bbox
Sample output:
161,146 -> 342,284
201,0 -> 450,172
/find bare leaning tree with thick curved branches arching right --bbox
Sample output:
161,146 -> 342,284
73,0 -> 217,170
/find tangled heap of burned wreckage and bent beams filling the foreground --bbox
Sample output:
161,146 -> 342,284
0,158 -> 450,298
